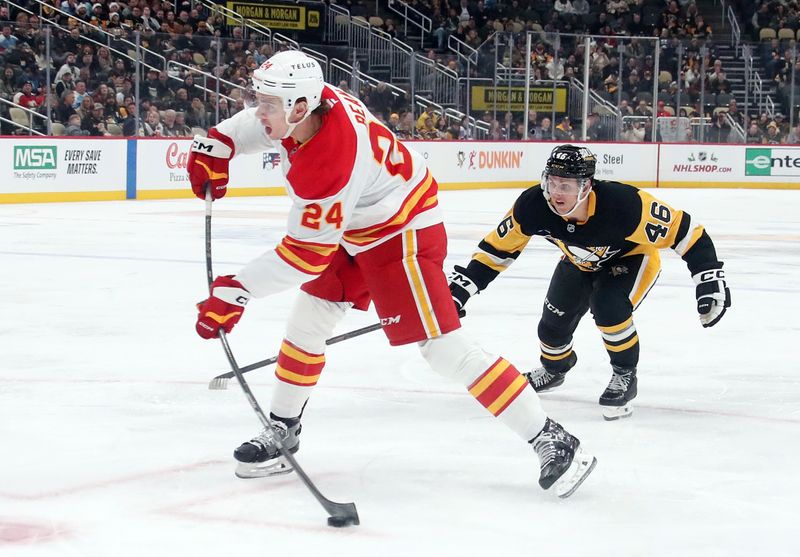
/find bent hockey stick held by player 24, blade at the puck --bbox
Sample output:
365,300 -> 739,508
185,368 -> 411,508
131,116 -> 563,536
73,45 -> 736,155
206,185 -> 360,527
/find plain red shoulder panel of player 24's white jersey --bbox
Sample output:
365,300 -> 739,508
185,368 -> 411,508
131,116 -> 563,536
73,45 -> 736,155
283,85 -> 358,199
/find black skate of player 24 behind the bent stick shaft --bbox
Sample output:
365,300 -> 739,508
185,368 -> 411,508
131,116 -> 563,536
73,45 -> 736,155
233,414 -> 301,478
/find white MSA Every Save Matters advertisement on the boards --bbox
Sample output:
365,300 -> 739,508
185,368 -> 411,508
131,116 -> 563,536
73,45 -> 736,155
0,137 -> 127,194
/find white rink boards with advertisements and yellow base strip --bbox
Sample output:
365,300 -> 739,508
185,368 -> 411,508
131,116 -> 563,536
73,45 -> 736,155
0,137 -> 800,203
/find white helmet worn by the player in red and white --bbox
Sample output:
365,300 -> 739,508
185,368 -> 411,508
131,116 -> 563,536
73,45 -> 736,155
253,50 -> 325,137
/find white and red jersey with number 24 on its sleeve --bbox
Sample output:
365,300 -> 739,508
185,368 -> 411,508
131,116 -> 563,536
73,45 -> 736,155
217,85 -> 442,297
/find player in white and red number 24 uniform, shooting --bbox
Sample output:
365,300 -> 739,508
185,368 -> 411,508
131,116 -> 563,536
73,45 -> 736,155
188,51 -> 596,497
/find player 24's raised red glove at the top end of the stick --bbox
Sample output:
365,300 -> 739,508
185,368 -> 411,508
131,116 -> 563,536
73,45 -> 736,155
186,128 -> 234,199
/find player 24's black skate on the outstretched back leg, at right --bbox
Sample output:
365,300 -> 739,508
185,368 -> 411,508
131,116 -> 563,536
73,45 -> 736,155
530,418 -> 597,499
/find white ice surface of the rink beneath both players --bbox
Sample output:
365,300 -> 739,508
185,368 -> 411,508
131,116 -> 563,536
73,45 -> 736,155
0,190 -> 800,557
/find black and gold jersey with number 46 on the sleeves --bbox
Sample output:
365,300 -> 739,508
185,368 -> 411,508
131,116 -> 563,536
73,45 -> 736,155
467,180 -> 717,290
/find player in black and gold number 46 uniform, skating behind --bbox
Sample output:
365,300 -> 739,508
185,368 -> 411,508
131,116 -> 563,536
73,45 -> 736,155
450,145 -> 731,420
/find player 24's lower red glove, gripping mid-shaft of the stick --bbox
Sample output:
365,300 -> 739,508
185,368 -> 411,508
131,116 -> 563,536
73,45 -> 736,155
195,275 -> 250,338
